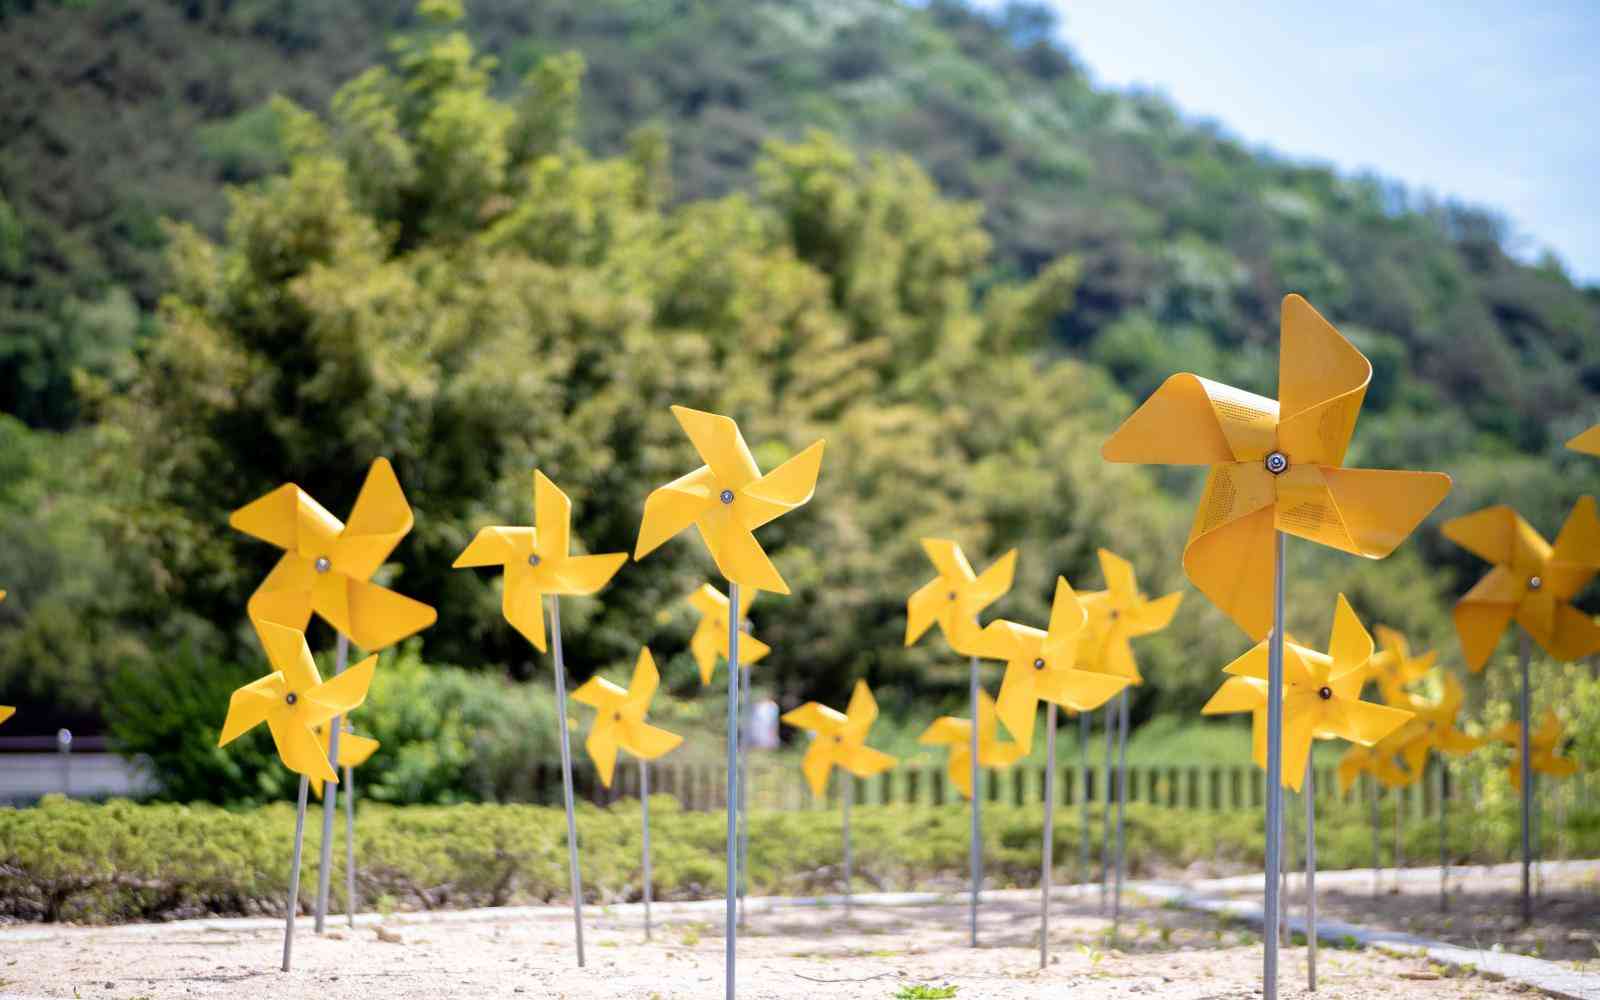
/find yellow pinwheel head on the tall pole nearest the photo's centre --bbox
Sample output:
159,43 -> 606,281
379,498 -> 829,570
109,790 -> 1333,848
634,406 -> 822,594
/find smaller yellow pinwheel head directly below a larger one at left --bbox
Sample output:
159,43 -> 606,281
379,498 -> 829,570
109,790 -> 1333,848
216,621 -> 378,782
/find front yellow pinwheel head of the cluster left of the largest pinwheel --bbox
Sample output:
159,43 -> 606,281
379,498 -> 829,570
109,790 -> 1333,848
978,576 -> 1128,747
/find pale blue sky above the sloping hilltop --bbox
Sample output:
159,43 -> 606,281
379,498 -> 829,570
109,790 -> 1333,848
1024,0 -> 1600,283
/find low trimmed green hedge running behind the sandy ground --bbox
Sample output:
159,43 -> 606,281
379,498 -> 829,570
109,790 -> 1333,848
0,795 -> 1600,923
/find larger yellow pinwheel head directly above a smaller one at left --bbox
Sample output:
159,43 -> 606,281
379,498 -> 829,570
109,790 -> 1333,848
227,459 -> 437,651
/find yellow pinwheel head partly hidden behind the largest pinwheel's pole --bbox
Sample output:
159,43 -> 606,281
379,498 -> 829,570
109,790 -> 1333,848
1224,594 -> 1411,792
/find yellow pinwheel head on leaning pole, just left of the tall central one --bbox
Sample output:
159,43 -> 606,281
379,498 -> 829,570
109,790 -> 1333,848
453,469 -> 627,653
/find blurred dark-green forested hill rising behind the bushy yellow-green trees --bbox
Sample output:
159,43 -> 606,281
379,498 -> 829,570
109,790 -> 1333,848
0,0 -> 1600,444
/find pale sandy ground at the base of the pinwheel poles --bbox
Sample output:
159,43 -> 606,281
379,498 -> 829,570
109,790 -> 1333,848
0,891 -> 1542,1000
